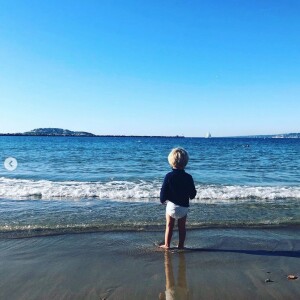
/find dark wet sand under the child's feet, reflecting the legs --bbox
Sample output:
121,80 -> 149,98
0,227 -> 300,299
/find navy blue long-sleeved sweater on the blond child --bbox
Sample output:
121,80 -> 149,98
160,169 -> 197,207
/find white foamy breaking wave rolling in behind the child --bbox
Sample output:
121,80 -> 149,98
0,177 -> 300,203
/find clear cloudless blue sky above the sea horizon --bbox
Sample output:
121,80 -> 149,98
0,0 -> 300,137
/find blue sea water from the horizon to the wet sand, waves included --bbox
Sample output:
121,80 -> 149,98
0,136 -> 300,237
